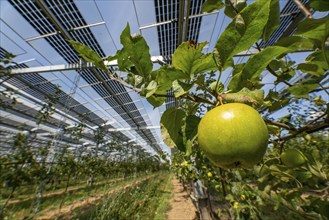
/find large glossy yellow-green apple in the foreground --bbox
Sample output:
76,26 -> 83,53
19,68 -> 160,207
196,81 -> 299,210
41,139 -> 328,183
198,103 -> 268,169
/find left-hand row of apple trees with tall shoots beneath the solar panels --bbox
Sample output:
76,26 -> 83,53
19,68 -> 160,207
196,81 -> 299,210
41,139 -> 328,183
0,62 -> 168,218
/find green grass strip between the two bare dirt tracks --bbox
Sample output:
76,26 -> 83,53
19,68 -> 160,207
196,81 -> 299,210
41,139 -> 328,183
70,172 -> 172,220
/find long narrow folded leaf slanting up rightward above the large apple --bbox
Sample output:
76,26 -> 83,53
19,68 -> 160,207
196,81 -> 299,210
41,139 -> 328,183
228,46 -> 290,91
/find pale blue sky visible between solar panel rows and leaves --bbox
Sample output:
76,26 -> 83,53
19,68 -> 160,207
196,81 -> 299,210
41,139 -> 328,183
0,0 -> 326,155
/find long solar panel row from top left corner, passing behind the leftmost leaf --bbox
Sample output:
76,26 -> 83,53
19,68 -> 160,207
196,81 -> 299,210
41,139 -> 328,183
9,0 -> 160,152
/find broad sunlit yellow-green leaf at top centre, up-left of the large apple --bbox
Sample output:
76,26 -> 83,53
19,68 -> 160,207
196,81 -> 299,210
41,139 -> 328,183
172,42 -> 217,79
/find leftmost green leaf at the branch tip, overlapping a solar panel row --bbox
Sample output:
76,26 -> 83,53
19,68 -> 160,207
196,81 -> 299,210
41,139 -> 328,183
69,40 -> 107,71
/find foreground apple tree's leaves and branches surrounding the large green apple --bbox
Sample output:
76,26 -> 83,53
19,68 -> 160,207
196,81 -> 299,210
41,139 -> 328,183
30,0 -> 329,219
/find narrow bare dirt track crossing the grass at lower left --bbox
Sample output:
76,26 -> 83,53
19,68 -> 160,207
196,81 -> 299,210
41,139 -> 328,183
36,176 -> 153,220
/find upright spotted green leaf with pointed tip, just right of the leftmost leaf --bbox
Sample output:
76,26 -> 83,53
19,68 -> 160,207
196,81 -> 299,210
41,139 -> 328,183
117,24 -> 153,81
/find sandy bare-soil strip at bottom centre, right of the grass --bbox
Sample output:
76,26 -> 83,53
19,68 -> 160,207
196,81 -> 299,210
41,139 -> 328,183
167,179 -> 198,220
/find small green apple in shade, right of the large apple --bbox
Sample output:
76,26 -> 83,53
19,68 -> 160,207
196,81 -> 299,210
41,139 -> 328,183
281,149 -> 306,168
